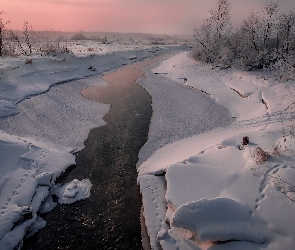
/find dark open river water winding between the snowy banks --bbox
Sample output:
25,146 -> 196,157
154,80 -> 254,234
22,55 -> 169,250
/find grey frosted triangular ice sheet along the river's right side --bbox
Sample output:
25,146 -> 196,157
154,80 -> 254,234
137,57 -> 233,166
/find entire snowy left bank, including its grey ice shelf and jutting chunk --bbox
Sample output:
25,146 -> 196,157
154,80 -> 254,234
0,46 -> 180,250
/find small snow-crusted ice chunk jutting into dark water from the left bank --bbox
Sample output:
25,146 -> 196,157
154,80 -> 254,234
55,179 -> 91,204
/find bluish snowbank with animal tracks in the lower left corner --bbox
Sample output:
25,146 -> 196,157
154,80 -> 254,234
0,131 -> 75,249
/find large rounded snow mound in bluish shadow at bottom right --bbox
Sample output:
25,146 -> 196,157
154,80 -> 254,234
171,198 -> 269,243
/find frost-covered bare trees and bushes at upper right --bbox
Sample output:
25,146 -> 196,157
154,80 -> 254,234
193,0 -> 295,80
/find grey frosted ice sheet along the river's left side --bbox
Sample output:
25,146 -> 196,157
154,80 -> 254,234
0,77 -> 110,151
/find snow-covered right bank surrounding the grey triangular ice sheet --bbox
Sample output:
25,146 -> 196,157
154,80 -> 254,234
138,53 -> 295,250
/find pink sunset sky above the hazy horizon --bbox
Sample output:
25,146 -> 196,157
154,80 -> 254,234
0,0 -> 295,34
